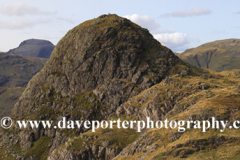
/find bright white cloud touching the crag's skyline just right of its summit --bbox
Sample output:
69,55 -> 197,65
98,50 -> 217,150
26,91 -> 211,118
124,14 -> 160,34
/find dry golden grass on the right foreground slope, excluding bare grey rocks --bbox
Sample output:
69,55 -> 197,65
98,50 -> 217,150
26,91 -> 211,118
114,67 -> 240,160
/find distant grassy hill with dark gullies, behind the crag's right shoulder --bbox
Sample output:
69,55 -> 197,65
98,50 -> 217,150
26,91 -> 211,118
176,39 -> 240,72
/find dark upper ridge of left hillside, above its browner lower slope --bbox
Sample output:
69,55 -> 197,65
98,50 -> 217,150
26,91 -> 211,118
0,53 -> 47,87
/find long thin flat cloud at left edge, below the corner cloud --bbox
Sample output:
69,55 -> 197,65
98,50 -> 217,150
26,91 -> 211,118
0,19 -> 50,29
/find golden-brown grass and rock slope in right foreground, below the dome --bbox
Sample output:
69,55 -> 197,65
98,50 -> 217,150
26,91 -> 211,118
113,70 -> 240,160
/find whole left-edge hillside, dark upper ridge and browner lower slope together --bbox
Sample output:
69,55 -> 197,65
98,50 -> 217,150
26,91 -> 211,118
0,52 -> 47,118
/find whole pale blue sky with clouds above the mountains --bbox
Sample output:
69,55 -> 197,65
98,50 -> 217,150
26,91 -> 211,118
0,0 -> 240,52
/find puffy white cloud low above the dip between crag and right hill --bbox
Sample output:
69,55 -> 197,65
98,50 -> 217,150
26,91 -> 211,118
154,32 -> 190,52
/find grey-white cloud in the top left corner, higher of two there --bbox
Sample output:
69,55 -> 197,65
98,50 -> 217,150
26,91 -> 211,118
1,3 -> 51,16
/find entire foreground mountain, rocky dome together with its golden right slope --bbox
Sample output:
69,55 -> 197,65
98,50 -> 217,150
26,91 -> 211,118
0,14 -> 240,160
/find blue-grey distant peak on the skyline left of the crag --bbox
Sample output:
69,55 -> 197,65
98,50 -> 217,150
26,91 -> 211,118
7,39 -> 55,58
